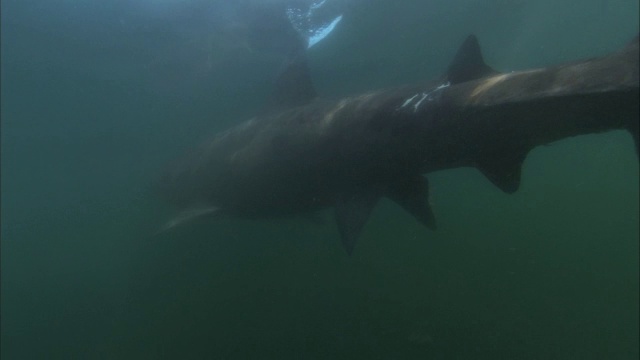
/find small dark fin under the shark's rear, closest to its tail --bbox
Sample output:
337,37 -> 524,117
476,151 -> 527,194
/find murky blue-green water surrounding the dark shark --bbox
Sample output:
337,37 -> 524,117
1,0 -> 639,359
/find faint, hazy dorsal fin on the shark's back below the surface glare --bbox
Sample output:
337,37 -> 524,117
264,49 -> 317,113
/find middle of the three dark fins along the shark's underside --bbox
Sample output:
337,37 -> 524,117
387,175 -> 436,230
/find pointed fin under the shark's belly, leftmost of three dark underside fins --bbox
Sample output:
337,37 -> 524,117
335,191 -> 380,255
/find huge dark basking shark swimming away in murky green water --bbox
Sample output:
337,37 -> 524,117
161,35 -> 640,254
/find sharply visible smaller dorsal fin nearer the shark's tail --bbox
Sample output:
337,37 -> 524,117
447,35 -> 498,85
